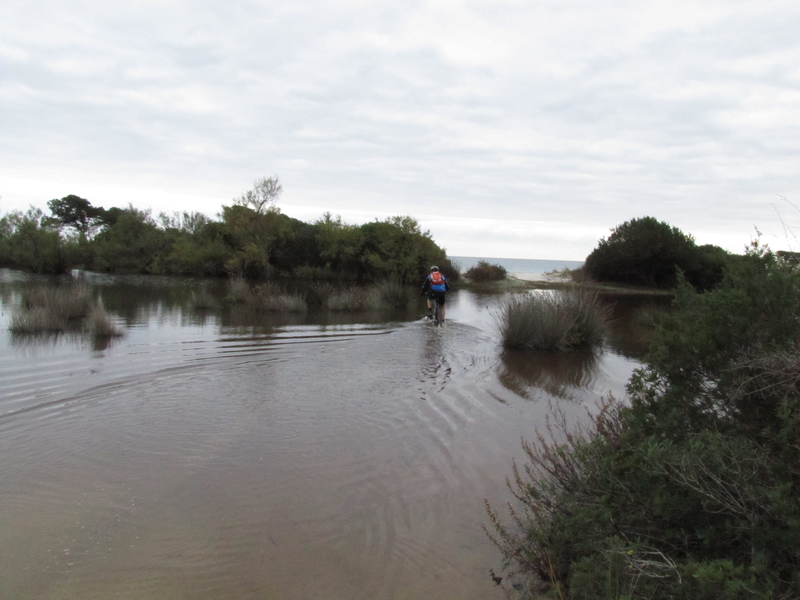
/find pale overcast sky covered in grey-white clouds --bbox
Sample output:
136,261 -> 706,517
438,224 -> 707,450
0,0 -> 800,260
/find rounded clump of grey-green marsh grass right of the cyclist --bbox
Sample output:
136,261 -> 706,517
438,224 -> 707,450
494,290 -> 611,350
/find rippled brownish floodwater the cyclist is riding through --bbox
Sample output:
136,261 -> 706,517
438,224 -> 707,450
0,270 -> 664,600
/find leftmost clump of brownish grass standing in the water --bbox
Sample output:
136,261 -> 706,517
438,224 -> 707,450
9,285 -> 122,337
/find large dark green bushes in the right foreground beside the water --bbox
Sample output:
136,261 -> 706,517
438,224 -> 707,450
487,246 -> 800,600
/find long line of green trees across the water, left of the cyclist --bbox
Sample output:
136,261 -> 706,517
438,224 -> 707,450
0,178 -> 459,283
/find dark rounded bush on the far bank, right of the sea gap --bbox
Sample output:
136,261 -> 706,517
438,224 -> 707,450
583,217 -> 728,289
